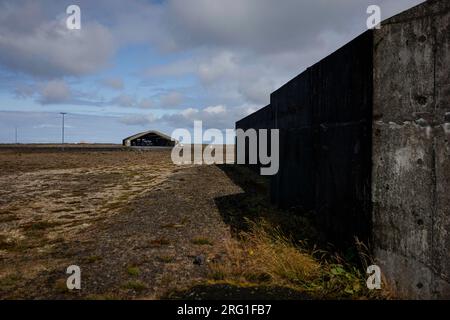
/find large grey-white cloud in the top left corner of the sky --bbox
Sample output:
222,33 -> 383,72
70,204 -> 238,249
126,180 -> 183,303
0,1 -> 115,77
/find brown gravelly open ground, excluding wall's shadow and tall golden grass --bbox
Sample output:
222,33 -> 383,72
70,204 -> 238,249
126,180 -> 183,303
0,148 -> 246,299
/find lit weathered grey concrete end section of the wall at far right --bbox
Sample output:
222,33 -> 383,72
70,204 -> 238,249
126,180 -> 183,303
372,1 -> 450,298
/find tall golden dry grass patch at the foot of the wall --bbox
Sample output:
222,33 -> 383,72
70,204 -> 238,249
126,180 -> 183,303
209,222 -> 381,299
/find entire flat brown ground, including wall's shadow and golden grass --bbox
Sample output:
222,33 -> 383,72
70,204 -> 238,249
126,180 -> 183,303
0,146 -> 374,299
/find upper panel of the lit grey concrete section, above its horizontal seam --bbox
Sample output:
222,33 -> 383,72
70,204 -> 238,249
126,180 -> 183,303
374,12 -> 435,123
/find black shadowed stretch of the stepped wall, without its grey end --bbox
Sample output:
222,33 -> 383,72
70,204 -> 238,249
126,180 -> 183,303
236,32 -> 372,244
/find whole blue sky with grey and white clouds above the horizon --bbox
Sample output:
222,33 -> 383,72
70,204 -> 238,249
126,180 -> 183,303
0,0 -> 422,143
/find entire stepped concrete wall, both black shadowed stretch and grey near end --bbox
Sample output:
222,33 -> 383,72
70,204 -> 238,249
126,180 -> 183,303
236,0 -> 450,298
